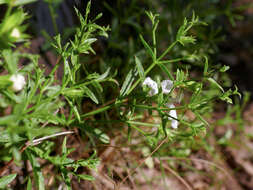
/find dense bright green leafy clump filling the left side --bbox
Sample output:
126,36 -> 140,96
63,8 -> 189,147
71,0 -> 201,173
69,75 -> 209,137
0,2 -> 107,190
